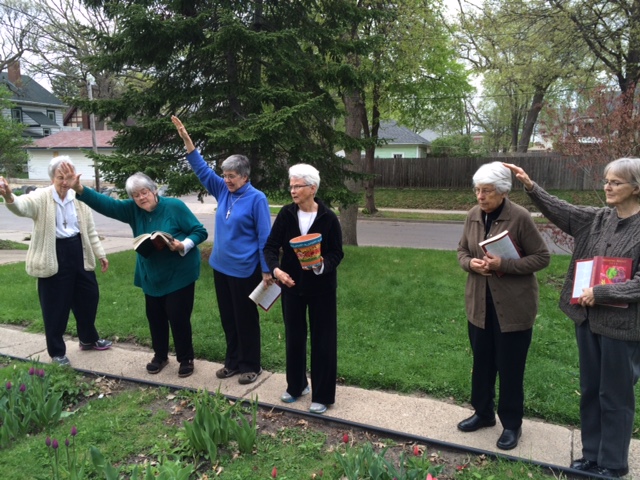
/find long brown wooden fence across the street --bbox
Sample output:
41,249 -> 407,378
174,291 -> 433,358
361,155 -> 594,190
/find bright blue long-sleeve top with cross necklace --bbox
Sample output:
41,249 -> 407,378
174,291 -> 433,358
187,150 -> 271,278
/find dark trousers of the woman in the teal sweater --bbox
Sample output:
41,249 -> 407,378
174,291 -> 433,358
144,282 -> 196,362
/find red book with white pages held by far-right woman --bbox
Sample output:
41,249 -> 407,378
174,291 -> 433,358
570,256 -> 633,308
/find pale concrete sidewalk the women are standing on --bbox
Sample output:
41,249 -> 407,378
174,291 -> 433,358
0,224 -> 640,478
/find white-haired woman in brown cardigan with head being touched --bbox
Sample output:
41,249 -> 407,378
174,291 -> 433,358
458,162 -> 550,450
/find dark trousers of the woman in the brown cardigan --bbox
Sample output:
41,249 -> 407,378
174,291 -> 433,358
469,302 -> 532,430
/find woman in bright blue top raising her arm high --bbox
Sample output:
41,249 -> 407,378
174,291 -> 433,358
171,116 -> 271,385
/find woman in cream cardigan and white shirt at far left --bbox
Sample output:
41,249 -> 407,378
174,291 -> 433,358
0,156 -> 111,365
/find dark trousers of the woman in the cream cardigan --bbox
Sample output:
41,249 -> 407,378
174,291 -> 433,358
38,235 -> 100,357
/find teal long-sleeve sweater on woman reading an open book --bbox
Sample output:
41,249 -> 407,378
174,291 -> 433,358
76,187 -> 208,297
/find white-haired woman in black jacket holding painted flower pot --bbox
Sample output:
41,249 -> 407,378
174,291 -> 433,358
264,164 -> 344,414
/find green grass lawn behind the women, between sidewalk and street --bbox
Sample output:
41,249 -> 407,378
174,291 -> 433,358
0,247 -> 640,436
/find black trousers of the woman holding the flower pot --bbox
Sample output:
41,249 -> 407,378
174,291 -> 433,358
282,291 -> 338,405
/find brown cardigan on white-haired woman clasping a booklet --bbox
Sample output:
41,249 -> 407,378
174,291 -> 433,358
458,198 -> 551,332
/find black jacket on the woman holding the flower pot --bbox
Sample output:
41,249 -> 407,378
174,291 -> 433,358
264,198 -> 344,295
